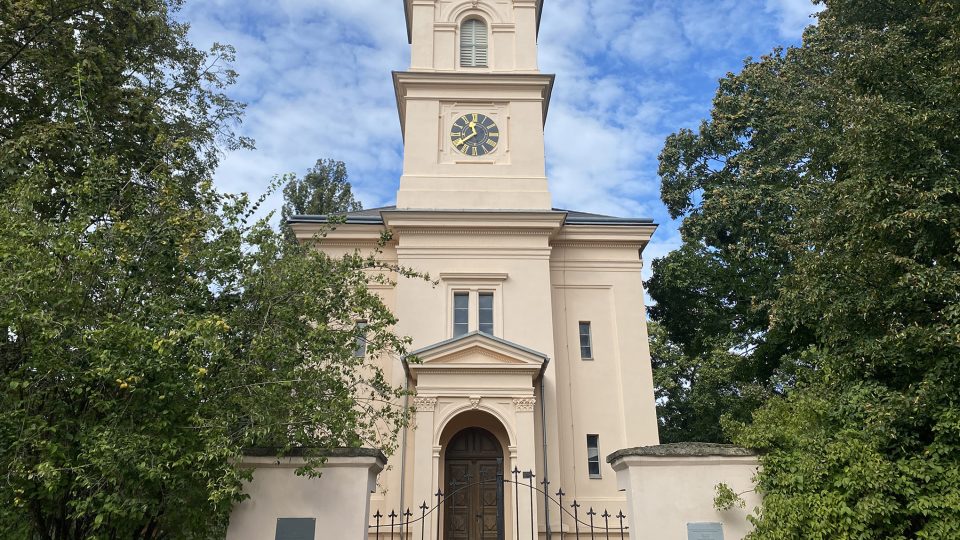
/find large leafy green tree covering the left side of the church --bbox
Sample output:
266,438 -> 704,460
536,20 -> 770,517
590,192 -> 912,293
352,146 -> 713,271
0,0 -> 407,540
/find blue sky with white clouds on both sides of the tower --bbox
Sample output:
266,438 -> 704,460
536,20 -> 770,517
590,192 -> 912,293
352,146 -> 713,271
177,0 -> 817,278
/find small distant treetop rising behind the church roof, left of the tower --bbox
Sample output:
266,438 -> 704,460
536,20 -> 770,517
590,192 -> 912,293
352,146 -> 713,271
280,159 -> 363,222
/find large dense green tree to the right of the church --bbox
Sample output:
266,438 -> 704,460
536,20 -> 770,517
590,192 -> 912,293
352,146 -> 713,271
651,0 -> 960,539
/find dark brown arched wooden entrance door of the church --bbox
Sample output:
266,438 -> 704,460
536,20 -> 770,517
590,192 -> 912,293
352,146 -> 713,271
443,428 -> 503,540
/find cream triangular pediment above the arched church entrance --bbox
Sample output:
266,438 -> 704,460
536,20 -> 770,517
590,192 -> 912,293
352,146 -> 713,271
404,332 -> 548,380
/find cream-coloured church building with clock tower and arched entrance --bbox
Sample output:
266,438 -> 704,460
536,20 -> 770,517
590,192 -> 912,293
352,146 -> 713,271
291,0 -> 659,539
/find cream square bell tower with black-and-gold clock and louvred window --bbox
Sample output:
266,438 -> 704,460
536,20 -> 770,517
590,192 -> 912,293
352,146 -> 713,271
393,0 -> 554,210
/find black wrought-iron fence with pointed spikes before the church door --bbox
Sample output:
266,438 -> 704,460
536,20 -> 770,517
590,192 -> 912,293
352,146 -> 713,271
369,468 -> 629,540
